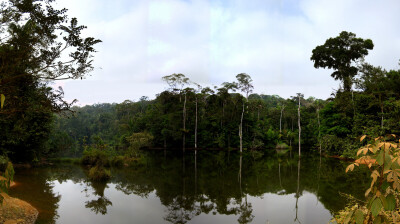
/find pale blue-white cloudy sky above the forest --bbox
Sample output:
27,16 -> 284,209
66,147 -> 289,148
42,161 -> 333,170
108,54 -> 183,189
53,0 -> 400,105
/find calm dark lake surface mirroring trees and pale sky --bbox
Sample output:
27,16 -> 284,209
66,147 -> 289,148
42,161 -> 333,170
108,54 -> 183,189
11,152 -> 369,224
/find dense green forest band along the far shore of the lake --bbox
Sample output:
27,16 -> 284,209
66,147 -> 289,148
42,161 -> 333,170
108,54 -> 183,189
45,64 -> 400,156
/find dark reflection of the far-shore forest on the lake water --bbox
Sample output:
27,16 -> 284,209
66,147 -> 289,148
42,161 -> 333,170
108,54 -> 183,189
113,151 -> 368,223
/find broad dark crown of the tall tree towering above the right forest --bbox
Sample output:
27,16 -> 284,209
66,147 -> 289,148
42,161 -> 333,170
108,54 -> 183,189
310,31 -> 374,92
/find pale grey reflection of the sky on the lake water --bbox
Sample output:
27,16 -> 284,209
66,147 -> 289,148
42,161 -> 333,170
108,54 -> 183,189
53,180 -> 332,224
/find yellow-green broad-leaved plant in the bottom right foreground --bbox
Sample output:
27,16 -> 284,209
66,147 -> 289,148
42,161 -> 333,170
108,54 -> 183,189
336,134 -> 400,224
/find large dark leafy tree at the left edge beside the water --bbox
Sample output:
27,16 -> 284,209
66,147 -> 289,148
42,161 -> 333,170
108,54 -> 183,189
0,0 -> 100,160
